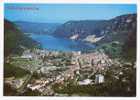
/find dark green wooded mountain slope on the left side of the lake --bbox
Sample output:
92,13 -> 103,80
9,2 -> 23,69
4,19 -> 40,56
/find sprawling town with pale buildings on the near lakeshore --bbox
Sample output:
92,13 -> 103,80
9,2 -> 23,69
4,49 -> 135,96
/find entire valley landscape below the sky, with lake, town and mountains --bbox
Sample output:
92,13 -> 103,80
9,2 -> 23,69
4,14 -> 137,96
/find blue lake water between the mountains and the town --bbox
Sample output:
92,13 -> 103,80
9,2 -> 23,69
30,34 -> 95,51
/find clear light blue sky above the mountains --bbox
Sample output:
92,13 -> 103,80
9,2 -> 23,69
4,3 -> 137,23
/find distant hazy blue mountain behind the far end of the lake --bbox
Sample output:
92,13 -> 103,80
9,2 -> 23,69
15,21 -> 60,34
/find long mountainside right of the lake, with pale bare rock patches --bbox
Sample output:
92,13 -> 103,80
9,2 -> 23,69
53,14 -> 137,61
